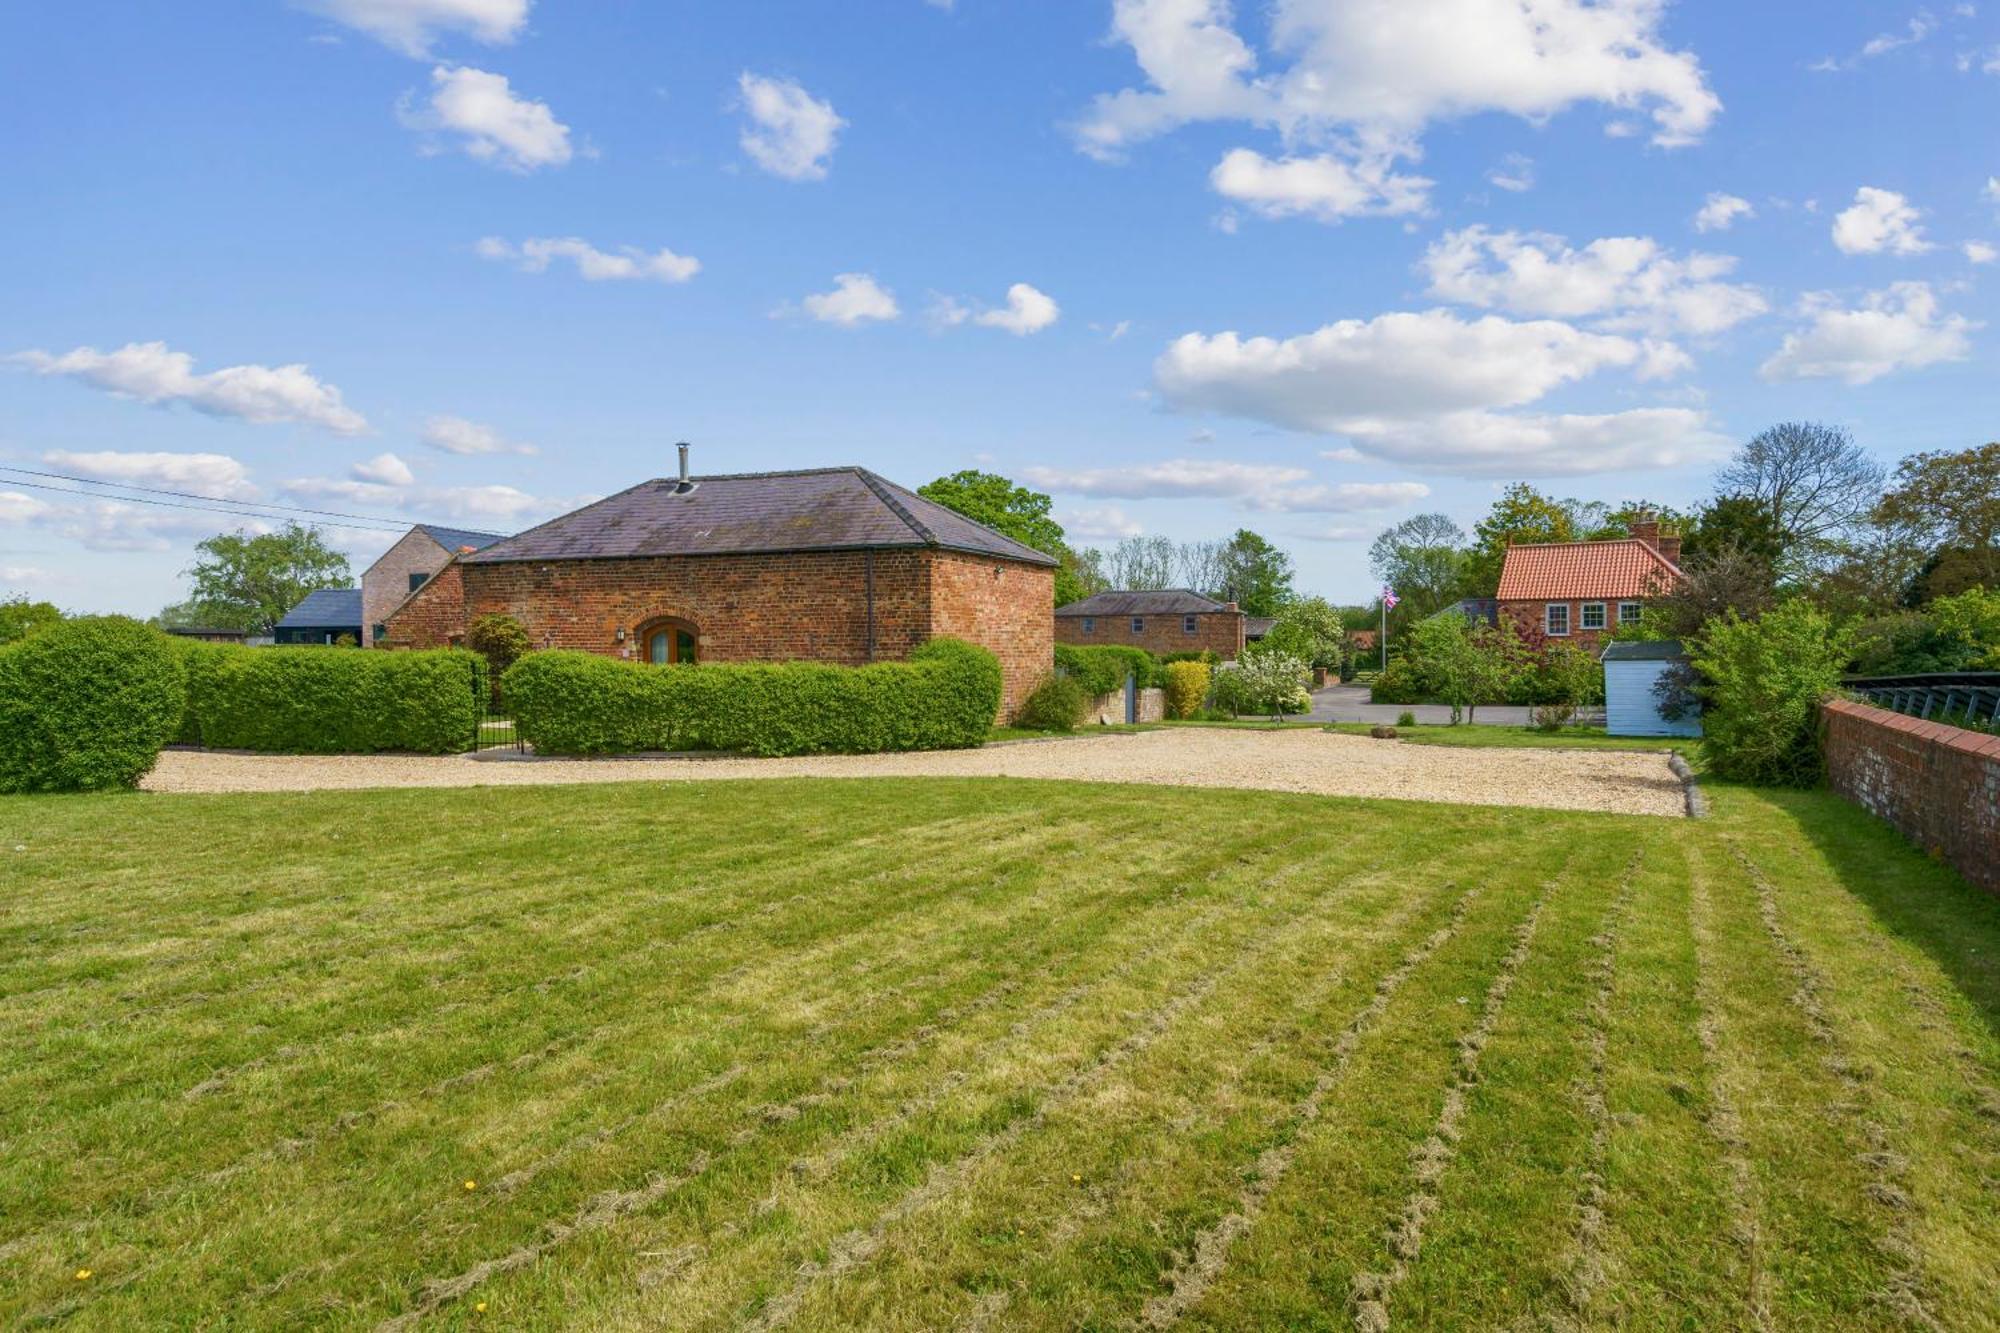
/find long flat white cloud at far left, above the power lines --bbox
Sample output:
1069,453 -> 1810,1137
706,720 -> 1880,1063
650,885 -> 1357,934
14,342 -> 368,434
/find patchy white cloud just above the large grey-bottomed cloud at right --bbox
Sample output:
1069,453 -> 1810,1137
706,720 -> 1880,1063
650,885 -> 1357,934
1422,226 -> 1768,334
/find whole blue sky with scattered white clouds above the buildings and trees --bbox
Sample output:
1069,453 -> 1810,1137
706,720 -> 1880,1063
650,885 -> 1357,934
0,0 -> 2000,614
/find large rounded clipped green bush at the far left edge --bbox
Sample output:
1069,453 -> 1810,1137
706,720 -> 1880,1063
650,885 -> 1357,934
0,616 -> 186,793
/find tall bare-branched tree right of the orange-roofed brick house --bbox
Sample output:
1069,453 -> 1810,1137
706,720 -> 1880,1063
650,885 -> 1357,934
1716,420 -> 1882,576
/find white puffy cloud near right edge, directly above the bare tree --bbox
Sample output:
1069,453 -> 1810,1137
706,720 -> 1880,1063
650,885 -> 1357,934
1758,282 -> 1980,384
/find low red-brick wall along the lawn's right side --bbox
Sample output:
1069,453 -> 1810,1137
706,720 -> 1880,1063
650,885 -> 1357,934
1820,699 -> 2000,893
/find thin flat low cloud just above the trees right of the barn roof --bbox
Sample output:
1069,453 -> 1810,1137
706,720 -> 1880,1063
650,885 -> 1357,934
1022,458 -> 1430,514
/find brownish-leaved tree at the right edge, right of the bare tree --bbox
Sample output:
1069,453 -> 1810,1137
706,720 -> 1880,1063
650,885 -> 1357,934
1870,444 -> 2000,602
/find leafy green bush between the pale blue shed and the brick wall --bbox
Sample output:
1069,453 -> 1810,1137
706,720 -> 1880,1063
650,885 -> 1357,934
1694,600 -> 1846,787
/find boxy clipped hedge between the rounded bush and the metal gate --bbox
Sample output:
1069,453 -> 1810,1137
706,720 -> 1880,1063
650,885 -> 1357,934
178,644 -> 486,755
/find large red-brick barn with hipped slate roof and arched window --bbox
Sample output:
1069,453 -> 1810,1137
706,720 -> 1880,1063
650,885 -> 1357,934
382,458 -> 1056,717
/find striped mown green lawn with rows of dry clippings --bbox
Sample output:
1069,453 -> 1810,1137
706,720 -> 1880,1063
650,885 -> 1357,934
0,781 -> 2000,1329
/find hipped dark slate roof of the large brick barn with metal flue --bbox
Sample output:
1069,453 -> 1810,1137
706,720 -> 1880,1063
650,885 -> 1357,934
460,466 -> 1056,564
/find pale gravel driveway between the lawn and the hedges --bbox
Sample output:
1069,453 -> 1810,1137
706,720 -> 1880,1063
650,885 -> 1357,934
142,727 -> 1686,815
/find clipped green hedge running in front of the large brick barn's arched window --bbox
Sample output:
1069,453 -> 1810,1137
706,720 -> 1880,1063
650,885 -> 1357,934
502,638 -> 1000,755
